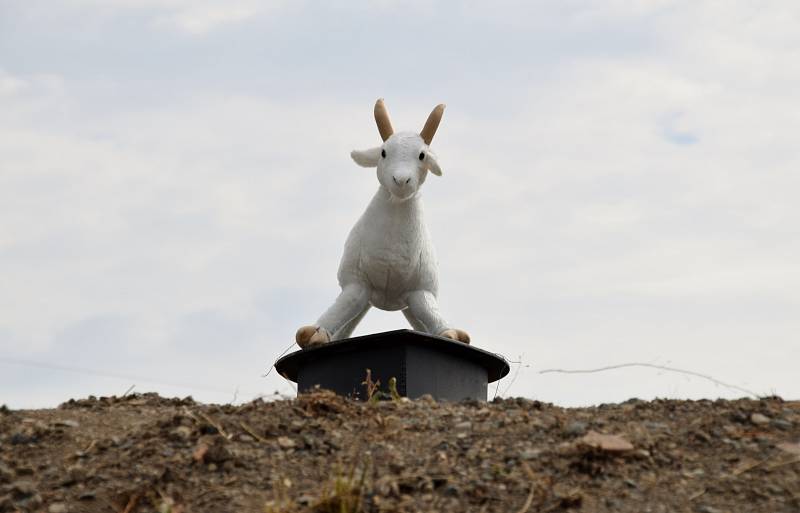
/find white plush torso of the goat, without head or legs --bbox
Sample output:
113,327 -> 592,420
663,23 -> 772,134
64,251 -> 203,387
338,187 -> 439,310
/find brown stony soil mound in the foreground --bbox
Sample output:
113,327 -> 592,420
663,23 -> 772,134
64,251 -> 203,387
0,391 -> 800,513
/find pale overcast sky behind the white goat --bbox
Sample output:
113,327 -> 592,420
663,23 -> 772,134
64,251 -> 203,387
0,0 -> 800,408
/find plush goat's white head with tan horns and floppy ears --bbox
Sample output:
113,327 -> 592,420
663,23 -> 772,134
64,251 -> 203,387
350,99 -> 444,201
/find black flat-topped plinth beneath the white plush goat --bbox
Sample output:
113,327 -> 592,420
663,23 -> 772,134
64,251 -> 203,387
275,330 -> 509,401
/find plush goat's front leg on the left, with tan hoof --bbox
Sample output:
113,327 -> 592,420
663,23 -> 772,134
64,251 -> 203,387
295,283 -> 369,348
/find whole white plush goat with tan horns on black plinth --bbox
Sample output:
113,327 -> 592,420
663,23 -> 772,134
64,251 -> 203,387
295,100 -> 469,347
